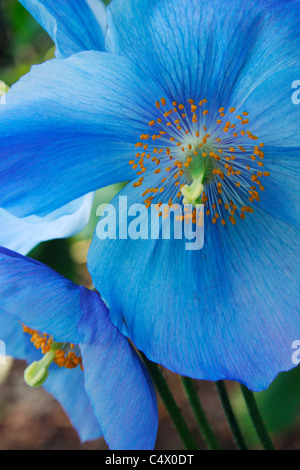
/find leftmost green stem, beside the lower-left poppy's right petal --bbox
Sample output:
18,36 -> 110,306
142,354 -> 197,450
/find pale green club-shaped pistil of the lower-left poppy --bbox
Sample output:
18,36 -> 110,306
24,343 -> 61,388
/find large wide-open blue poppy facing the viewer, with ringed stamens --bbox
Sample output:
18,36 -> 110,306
0,0 -> 300,390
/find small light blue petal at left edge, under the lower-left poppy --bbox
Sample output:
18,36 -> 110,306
0,309 -> 26,359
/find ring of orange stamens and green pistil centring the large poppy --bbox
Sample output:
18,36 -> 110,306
129,98 -> 270,225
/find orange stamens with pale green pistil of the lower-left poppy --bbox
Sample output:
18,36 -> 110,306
23,325 -> 83,387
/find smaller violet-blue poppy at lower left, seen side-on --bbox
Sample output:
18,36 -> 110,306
0,248 -> 157,450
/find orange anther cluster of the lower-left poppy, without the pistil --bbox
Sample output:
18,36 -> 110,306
22,325 -> 83,370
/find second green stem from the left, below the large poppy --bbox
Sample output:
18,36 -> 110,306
181,377 -> 220,450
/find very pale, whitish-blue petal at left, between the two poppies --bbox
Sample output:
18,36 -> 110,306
0,194 -> 93,255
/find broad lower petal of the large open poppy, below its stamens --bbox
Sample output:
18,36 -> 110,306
88,184 -> 300,390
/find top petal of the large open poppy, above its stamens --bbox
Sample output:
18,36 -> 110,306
106,0 -> 300,106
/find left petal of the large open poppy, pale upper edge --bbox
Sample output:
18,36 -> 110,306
0,52 -> 161,217
